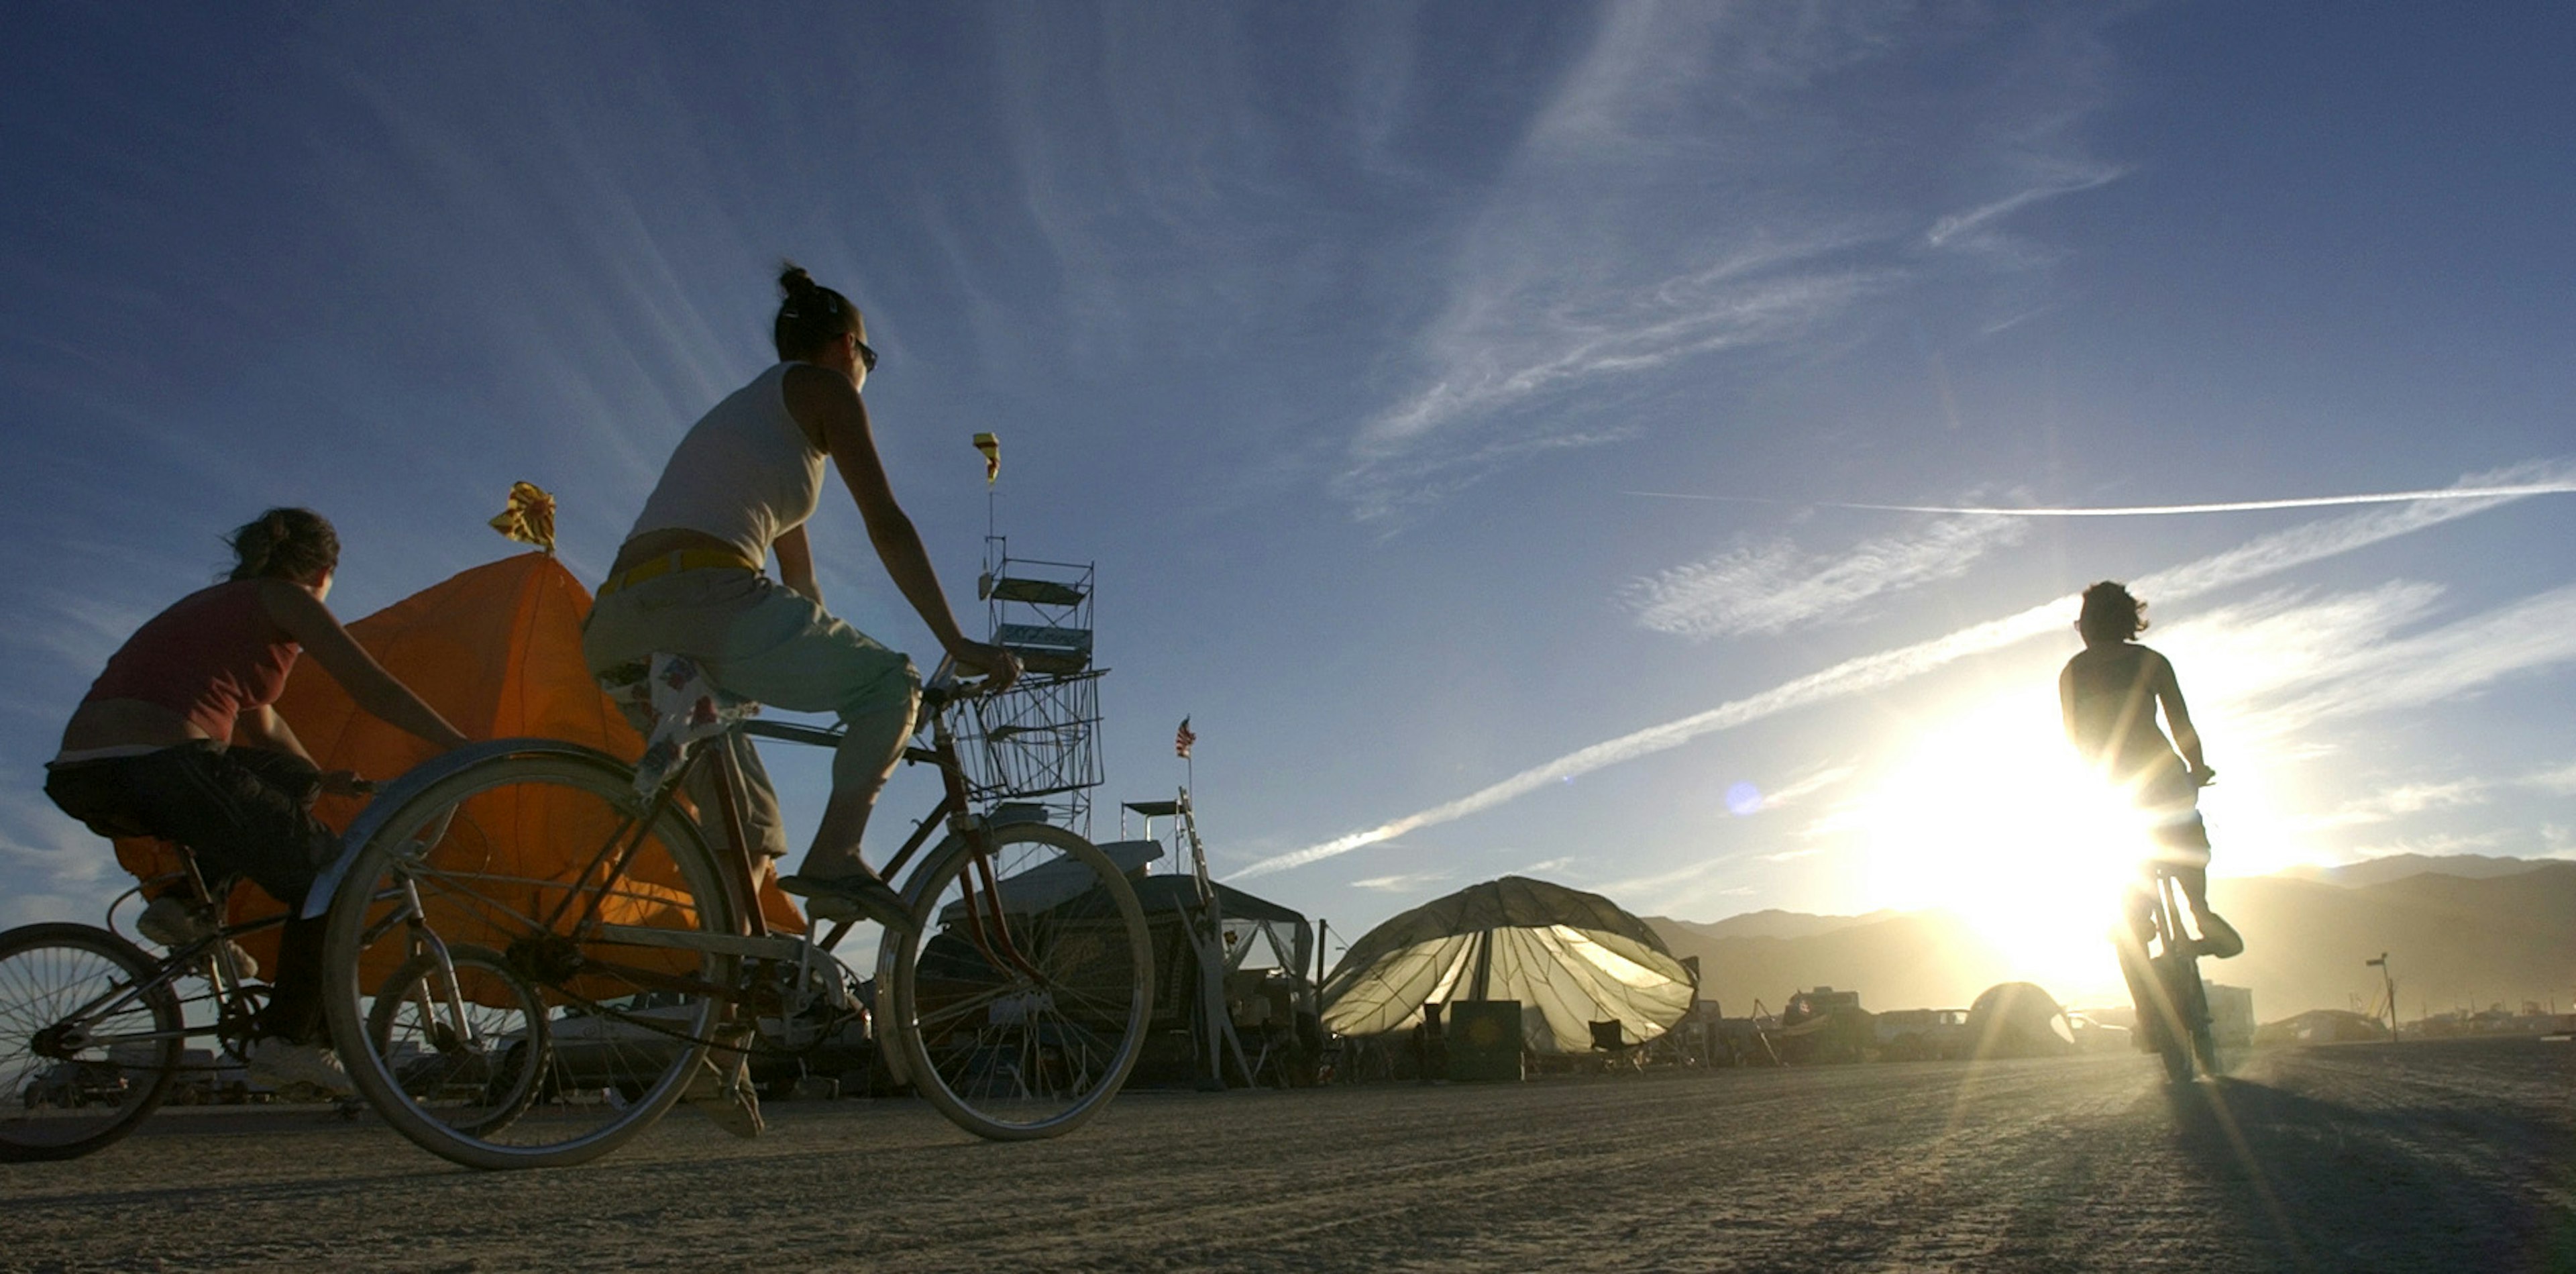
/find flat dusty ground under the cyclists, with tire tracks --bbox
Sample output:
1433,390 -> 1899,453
0,1043 -> 2576,1274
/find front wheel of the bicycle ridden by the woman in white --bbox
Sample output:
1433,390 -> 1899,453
894,824 -> 1154,1140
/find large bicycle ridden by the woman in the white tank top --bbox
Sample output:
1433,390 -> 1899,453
307,656 -> 1151,1169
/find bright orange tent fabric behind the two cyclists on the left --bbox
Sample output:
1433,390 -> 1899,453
116,553 -> 804,967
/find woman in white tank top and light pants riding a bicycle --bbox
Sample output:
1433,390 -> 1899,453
582,262 -> 1020,919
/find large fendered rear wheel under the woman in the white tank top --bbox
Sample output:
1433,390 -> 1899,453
325,744 -> 739,1169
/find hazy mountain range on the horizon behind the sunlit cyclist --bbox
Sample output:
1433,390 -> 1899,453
1649,855 -> 2576,1022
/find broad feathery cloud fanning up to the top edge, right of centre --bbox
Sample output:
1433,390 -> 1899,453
1334,3 -> 2117,517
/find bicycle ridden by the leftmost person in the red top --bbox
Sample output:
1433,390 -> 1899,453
0,847 -> 531,1163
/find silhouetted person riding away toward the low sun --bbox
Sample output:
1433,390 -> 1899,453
2058,579 -> 2246,960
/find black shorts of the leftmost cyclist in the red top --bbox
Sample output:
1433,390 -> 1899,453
44,739 -> 340,906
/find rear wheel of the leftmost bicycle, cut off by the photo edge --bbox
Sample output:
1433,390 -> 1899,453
0,924 -> 185,1163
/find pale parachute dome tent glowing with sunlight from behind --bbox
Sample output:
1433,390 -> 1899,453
1324,875 -> 1698,1053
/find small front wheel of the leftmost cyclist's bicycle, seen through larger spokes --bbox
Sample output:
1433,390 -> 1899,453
366,945 -> 551,1138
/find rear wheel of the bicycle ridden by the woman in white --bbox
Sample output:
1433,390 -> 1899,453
325,744 -> 739,1171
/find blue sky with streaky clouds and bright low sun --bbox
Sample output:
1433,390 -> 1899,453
0,3 -> 2576,973
